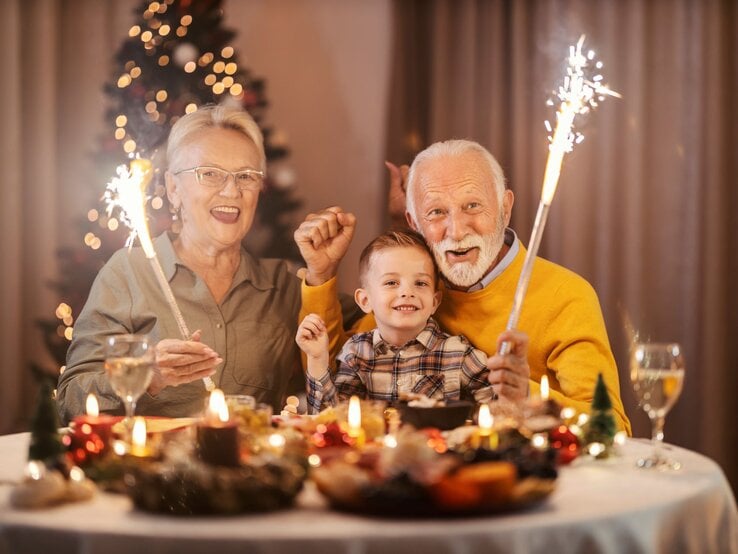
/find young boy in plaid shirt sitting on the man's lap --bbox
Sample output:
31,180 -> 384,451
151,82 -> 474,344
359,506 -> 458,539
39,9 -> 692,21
295,226 -> 493,413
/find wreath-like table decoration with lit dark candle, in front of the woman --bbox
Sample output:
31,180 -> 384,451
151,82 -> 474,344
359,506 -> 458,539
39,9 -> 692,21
125,410 -> 308,516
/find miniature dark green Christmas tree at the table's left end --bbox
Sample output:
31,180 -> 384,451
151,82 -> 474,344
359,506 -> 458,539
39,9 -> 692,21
28,380 -> 66,468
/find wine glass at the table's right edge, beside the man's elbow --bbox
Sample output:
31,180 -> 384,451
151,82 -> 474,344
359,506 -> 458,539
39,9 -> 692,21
630,342 -> 684,470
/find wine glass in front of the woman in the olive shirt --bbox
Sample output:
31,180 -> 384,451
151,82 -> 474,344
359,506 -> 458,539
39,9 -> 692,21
105,335 -> 155,438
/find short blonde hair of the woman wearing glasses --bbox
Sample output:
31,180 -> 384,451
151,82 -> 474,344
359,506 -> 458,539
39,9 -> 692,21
167,104 -> 266,171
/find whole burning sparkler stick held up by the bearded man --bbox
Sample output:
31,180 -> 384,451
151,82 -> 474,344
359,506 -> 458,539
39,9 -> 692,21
499,35 -> 620,354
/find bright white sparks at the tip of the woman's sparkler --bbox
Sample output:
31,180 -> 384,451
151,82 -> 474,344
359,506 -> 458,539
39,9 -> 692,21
103,159 -> 156,258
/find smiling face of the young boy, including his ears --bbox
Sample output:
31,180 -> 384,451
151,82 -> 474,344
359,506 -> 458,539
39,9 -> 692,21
354,246 -> 441,346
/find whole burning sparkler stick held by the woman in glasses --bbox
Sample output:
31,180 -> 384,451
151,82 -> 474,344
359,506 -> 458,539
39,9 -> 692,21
104,159 -> 215,391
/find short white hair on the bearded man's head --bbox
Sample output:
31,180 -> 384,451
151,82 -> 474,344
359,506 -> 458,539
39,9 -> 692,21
405,139 -> 505,227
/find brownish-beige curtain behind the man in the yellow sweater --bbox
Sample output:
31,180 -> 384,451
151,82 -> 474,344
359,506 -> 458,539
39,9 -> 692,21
388,0 -> 738,487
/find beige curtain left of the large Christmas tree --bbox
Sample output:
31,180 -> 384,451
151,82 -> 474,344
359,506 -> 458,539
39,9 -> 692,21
0,0 -> 134,433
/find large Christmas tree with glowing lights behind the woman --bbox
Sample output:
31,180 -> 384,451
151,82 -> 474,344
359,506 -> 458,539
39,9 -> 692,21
39,0 -> 300,378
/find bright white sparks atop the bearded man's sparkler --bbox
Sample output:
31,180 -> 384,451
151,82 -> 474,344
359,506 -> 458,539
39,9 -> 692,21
541,35 -> 620,206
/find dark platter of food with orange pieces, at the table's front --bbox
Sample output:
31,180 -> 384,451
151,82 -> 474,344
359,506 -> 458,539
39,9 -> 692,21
311,428 -> 557,517
